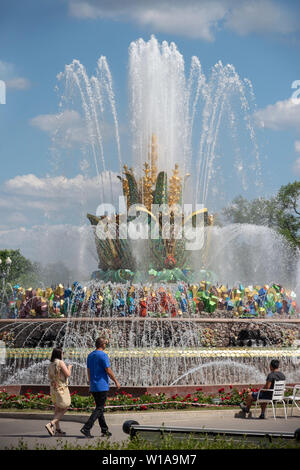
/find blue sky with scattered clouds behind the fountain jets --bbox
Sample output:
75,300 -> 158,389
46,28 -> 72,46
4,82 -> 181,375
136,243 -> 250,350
0,0 -> 300,272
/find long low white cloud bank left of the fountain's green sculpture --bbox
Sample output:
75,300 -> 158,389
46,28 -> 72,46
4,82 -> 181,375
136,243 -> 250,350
0,172 -> 122,227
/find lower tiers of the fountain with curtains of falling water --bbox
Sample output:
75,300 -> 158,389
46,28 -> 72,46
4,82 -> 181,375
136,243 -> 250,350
0,281 -> 300,386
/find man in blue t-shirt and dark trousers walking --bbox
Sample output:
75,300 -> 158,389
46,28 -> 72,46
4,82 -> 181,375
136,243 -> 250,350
80,338 -> 120,437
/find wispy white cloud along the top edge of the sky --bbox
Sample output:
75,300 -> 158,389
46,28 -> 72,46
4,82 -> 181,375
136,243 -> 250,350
69,0 -> 299,41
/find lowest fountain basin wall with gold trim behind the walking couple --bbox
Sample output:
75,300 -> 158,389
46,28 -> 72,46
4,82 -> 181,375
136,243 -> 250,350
0,347 -> 300,393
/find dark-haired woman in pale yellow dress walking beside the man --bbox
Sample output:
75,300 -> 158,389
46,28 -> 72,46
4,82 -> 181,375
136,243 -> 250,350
45,348 -> 72,436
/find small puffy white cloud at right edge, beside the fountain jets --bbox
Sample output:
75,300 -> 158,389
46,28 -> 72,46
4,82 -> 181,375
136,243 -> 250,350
255,98 -> 300,132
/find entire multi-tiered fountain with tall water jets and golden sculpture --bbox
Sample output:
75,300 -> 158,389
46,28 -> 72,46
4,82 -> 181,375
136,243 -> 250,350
0,37 -> 300,386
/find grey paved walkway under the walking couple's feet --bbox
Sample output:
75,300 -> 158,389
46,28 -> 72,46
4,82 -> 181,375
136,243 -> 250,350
0,409 -> 300,450
